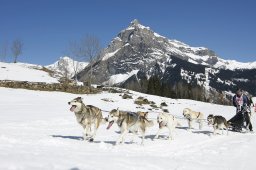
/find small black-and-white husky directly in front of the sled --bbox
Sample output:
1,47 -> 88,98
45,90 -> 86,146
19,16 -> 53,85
207,114 -> 229,135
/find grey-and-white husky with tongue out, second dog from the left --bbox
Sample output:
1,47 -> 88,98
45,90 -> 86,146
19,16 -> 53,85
107,109 -> 153,145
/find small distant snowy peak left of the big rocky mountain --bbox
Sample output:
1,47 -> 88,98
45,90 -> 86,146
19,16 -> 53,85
45,56 -> 88,78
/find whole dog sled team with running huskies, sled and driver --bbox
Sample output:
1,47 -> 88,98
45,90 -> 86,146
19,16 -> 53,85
68,89 -> 253,145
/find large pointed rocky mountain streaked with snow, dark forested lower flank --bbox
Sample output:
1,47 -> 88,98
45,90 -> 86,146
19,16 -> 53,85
78,20 -> 256,98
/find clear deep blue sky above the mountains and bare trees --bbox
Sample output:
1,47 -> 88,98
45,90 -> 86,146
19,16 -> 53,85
0,0 -> 256,65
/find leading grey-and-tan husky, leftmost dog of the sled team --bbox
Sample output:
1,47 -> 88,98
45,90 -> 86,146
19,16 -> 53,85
68,97 -> 103,142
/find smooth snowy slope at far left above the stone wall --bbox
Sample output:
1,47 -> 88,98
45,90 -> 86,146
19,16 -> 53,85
0,62 -> 58,83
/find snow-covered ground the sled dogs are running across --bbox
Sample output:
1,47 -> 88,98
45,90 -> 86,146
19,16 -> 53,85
0,88 -> 256,170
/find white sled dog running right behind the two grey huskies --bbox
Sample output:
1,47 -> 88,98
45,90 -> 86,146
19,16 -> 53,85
155,113 -> 179,140
